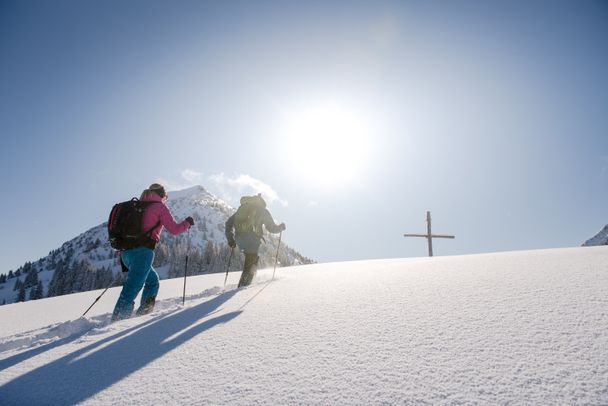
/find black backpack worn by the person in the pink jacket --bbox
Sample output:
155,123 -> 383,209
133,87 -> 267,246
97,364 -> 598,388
108,197 -> 160,251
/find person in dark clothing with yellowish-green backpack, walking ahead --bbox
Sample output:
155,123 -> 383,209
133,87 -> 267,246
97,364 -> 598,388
226,194 -> 285,287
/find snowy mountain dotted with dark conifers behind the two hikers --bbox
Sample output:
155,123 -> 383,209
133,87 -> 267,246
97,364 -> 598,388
0,186 -> 312,304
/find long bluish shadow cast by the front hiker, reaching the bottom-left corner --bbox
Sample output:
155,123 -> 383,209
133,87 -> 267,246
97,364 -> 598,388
0,290 -> 242,405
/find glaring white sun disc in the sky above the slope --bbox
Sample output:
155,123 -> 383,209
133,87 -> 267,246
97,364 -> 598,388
281,104 -> 370,187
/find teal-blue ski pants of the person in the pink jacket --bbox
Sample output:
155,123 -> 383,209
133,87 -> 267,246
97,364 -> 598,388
112,247 -> 159,320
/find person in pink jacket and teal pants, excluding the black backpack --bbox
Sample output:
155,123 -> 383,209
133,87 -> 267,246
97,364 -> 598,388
112,183 -> 194,321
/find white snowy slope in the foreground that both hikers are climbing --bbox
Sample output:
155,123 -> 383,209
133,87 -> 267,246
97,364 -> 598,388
0,247 -> 608,405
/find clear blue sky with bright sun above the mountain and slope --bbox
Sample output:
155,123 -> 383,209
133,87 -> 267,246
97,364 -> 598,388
0,1 -> 608,272
